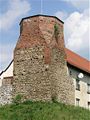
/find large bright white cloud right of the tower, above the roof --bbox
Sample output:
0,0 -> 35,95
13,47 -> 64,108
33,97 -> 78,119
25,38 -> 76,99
54,9 -> 90,58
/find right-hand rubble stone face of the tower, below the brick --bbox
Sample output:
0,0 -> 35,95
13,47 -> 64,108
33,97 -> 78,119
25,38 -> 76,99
50,48 -> 75,105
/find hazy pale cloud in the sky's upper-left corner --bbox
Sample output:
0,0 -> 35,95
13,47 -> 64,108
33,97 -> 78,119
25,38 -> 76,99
0,0 -> 31,30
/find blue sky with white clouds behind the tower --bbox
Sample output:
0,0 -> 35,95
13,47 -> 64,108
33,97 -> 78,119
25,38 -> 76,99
0,0 -> 90,71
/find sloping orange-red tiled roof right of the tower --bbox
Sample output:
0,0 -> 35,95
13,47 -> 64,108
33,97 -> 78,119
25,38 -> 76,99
65,48 -> 90,73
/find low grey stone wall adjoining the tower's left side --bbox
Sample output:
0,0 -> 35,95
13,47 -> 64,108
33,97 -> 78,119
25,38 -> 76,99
0,77 -> 13,105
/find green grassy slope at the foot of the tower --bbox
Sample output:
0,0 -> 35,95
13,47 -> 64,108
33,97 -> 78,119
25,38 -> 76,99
0,101 -> 90,120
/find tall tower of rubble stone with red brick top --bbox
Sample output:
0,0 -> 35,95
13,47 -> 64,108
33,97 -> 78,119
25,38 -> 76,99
13,15 -> 75,104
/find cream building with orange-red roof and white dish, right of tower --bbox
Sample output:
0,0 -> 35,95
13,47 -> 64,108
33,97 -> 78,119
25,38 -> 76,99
66,49 -> 90,109
